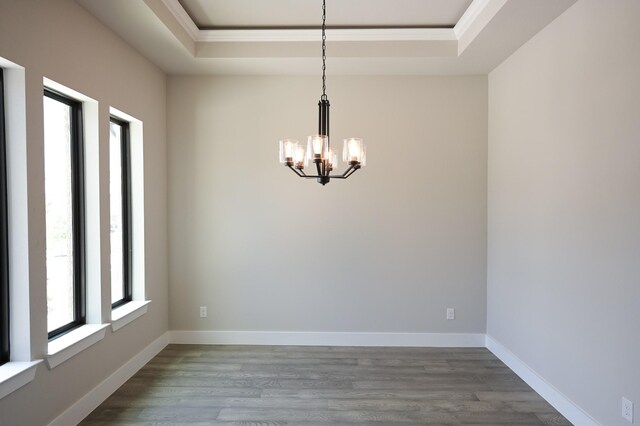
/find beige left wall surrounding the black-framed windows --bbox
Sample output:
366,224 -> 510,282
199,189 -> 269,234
0,0 -> 168,425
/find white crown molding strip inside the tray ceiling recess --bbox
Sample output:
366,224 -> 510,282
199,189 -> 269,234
161,0 -> 507,46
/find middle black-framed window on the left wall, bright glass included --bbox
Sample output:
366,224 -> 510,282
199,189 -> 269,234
44,89 -> 86,339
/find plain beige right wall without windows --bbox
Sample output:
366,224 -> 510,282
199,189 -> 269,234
487,0 -> 640,426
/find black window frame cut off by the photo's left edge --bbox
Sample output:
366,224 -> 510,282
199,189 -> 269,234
0,68 -> 11,365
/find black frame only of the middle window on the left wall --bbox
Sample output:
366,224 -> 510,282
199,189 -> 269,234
44,88 -> 87,340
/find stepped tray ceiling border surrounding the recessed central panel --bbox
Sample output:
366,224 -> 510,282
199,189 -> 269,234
76,0 -> 577,75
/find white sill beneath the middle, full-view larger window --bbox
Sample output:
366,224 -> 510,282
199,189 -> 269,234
45,324 -> 109,369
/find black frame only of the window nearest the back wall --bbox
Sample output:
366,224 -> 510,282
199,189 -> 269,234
109,116 -> 133,309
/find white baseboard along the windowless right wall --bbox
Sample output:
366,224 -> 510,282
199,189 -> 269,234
486,334 -> 601,426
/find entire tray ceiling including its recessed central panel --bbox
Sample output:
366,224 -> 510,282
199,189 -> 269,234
76,0 -> 576,75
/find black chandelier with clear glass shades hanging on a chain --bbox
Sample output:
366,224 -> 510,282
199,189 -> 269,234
280,0 -> 367,185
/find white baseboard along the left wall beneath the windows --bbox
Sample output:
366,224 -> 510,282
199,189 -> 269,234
49,332 -> 169,426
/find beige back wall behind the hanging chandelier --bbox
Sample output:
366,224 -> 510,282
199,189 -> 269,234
167,76 -> 487,333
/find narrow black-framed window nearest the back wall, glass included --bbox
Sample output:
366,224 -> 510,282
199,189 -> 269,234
109,117 -> 133,308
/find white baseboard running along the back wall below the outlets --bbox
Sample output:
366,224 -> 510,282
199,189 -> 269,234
169,331 -> 484,348
